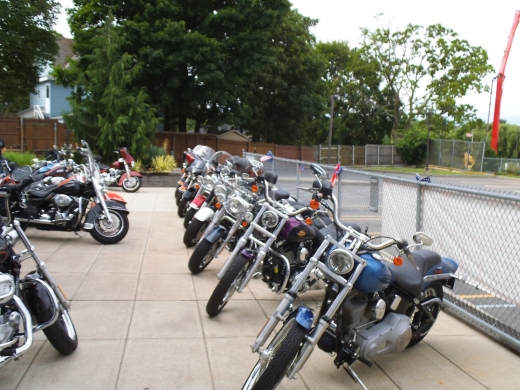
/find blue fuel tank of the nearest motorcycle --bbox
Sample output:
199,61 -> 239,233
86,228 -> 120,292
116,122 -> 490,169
354,253 -> 394,293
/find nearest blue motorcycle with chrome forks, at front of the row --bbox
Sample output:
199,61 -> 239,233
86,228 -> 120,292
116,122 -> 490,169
243,184 -> 464,390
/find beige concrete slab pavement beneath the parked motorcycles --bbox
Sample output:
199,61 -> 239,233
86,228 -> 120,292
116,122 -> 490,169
0,188 -> 520,390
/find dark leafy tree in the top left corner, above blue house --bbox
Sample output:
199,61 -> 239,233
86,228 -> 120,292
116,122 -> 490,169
0,0 -> 59,113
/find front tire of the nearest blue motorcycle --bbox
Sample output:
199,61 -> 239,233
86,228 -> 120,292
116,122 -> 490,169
242,317 -> 307,390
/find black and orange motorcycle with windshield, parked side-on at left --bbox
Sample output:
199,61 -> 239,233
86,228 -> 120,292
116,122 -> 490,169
2,141 -> 129,244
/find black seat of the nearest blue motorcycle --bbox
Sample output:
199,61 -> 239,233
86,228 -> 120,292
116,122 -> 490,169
389,249 -> 442,298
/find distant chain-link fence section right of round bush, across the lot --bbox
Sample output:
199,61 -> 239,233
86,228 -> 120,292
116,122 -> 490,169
428,139 -> 486,172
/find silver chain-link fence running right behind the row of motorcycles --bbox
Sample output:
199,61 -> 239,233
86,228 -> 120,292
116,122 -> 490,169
245,151 -> 520,351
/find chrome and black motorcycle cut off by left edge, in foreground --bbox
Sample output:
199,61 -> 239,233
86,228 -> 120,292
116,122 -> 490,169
0,212 -> 78,368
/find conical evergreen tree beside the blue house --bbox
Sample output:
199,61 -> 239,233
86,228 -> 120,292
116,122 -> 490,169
56,16 -> 158,158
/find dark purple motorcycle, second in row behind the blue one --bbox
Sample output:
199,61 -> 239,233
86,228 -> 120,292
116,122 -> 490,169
206,164 -> 359,317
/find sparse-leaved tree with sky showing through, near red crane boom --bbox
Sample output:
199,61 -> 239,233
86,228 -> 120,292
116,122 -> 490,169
362,24 -> 493,142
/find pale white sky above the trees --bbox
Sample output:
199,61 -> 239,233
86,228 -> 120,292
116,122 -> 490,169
55,0 -> 520,124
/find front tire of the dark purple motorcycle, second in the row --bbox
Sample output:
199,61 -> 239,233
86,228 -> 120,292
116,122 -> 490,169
206,255 -> 250,317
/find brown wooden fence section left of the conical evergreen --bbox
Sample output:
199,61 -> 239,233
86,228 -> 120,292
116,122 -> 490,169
0,117 -> 73,153
